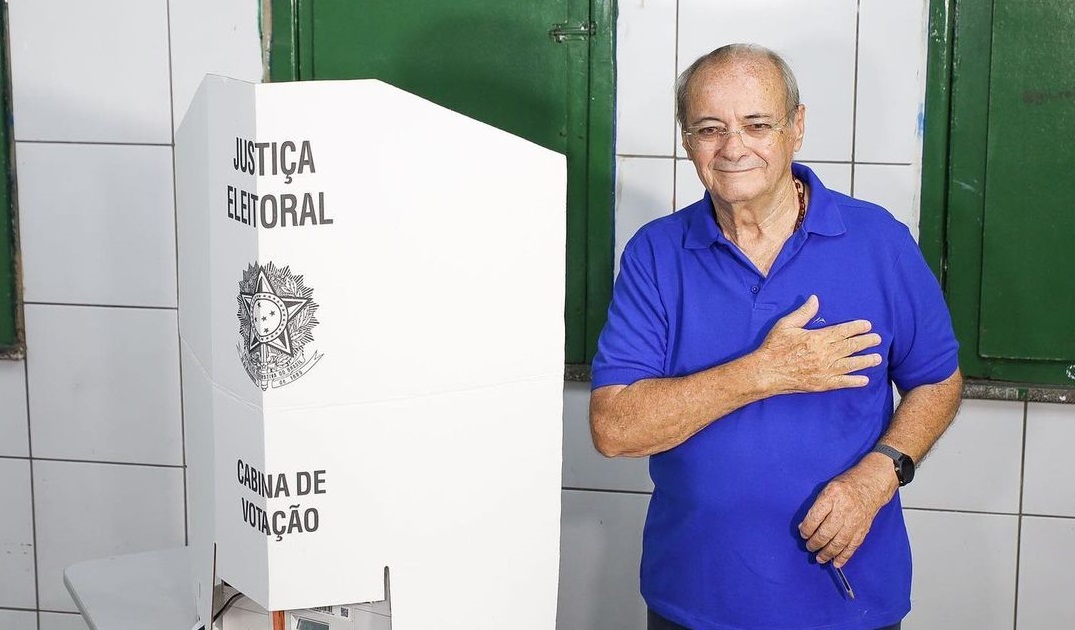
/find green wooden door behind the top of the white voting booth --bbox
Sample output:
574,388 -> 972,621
272,0 -> 613,362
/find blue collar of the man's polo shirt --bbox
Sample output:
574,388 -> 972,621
680,162 -> 847,249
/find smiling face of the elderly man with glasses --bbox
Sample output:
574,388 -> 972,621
684,59 -> 805,203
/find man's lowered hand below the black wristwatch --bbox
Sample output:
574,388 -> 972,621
799,453 -> 900,569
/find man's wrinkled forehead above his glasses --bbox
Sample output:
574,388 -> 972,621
687,57 -> 787,118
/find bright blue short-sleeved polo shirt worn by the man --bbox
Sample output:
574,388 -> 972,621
592,163 -> 957,630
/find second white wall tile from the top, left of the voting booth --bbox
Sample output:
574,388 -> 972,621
15,142 -> 175,307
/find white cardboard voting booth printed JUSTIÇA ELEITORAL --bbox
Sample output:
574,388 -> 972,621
175,76 -> 565,630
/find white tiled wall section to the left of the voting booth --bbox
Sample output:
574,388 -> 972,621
0,0 -> 261,630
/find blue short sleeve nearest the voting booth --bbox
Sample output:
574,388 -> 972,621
591,234 -> 668,389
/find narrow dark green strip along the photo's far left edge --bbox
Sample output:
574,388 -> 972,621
0,3 -> 25,358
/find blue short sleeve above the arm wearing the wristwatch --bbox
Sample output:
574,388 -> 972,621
889,233 -> 959,391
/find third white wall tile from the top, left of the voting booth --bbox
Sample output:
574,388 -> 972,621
26,304 -> 183,466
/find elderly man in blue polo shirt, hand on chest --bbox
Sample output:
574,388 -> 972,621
590,44 -> 962,630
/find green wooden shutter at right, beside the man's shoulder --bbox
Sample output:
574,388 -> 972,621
921,0 -> 1075,386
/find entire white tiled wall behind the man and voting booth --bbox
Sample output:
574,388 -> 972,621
0,0 -> 1075,630
